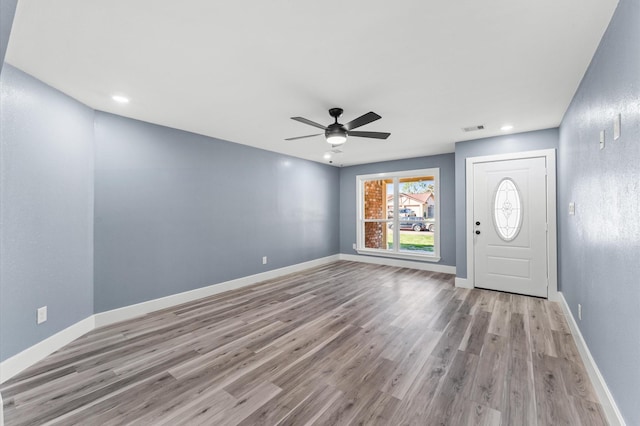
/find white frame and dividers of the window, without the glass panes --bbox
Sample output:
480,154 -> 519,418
356,167 -> 441,262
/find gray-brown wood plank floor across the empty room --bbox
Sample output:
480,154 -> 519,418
0,261 -> 606,426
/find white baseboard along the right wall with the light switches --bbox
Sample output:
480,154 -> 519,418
558,292 -> 626,426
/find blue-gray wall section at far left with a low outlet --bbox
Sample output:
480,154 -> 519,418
0,64 -> 93,360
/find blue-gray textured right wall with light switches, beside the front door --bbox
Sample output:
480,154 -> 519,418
558,0 -> 640,425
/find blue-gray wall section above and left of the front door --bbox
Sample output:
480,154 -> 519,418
455,129 -> 558,278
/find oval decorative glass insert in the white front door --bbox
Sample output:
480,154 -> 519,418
493,178 -> 522,241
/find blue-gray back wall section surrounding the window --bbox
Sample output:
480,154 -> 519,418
340,154 -> 456,266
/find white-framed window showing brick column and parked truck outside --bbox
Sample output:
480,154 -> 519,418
356,168 -> 440,262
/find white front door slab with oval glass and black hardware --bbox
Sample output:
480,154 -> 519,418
472,157 -> 549,297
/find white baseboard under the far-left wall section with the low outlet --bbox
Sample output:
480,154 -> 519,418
0,315 -> 95,383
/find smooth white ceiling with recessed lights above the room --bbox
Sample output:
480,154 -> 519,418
6,0 -> 617,165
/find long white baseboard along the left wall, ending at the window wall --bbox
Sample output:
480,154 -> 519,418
94,254 -> 338,327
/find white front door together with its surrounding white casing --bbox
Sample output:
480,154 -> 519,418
456,150 -> 558,300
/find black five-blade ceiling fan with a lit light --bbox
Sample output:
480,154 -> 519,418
285,108 -> 391,146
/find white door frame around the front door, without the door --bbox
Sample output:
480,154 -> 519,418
465,149 -> 560,302
